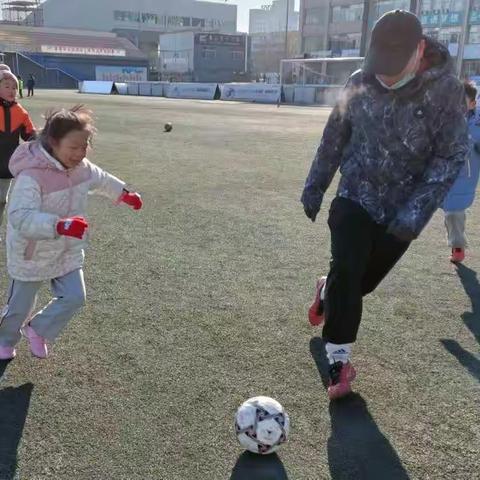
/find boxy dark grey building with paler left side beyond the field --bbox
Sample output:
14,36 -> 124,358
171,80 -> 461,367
158,32 -> 247,83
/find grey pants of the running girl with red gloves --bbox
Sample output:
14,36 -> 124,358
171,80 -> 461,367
0,269 -> 85,347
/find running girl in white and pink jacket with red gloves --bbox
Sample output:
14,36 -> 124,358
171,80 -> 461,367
0,106 -> 142,360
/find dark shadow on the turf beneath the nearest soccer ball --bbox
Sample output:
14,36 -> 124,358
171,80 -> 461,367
230,452 -> 288,480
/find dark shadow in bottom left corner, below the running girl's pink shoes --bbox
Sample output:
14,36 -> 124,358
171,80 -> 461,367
0,383 -> 33,480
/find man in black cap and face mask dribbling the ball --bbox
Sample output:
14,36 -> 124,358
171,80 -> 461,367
302,10 -> 469,399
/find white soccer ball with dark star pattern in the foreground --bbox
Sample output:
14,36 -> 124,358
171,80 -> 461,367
235,397 -> 290,455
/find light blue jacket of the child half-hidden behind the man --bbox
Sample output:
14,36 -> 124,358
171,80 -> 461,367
442,111 -> 480,212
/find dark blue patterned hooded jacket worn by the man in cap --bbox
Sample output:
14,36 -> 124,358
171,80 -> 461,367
302,39 -> 469,240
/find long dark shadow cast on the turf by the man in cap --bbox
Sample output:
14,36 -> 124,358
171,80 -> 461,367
310,338 -> 409,480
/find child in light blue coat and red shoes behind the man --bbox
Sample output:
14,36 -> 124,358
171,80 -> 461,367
442,82 -> 480,263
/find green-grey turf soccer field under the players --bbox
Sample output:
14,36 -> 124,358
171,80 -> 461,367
0,91 -> 480,480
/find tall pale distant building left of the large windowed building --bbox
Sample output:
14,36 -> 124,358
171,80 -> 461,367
248,0 -> 300,83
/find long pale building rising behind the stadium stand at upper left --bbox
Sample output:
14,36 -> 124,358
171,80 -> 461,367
42,0 -> 237,74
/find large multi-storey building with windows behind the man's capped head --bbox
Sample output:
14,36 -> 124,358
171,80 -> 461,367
300,0 -> 480,77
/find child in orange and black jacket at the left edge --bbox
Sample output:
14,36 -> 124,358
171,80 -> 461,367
0,69 -> 35,230
